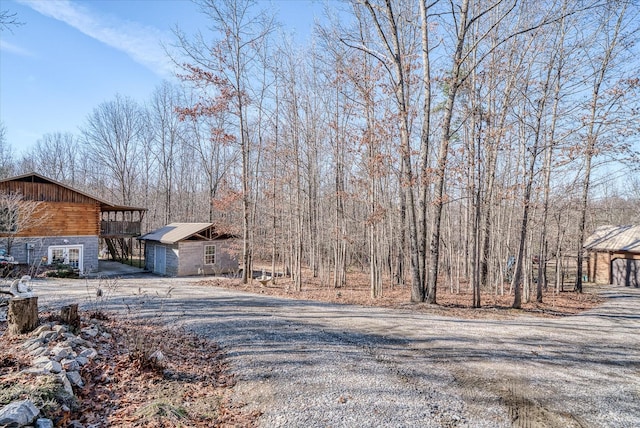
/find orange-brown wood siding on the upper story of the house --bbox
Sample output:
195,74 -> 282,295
17,200 -> 100,237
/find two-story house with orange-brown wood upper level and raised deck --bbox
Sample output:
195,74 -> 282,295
0,173 -> 146,272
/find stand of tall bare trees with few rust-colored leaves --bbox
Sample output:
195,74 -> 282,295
0,0 -> 640,307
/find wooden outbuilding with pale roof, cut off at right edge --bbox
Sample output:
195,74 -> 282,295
584,226 -> 640,287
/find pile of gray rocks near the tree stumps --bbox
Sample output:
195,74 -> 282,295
0,322 -> 111,428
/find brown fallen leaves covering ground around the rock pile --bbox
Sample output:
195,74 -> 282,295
0,314 -> 259,428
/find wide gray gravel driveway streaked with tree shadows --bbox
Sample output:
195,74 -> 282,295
35,276 -> 640,428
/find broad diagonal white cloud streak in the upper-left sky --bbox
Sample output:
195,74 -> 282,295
18,0 -> 173,77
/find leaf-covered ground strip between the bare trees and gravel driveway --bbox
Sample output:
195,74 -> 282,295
198,272 -> 604,319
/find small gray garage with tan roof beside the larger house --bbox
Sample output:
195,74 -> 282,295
138,223 -> 238,276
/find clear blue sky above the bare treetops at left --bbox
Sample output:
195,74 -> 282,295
0,0 -> 322,153
